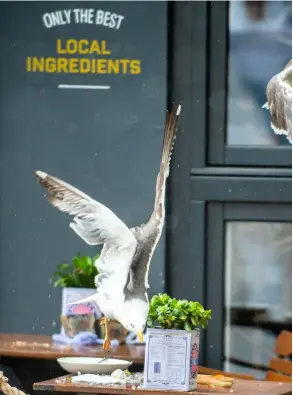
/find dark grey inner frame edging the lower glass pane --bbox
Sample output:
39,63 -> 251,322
204,201 -> 292,368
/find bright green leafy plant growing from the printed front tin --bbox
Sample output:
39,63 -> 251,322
147,294 -> 212,331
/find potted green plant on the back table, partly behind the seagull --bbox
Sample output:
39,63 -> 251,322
50,254 -> 101,337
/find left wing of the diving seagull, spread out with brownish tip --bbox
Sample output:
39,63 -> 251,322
36,171 -> 137,292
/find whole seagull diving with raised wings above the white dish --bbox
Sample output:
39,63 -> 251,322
35,105 -> 181,351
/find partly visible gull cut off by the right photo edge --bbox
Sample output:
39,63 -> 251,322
263,59 -> 292,144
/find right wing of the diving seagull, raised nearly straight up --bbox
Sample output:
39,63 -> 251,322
127,105 -> 181,292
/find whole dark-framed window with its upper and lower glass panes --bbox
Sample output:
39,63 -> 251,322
166,1 -> 292,377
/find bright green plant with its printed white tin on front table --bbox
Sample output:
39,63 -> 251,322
144,294 -> 212,391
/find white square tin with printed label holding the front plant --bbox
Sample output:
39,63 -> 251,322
144,328 -> 200,391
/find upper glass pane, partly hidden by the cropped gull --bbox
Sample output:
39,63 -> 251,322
227,1 -> 292,146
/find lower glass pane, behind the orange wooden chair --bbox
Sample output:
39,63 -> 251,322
225,222 -> 292,378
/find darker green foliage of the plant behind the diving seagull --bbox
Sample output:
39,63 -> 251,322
50,254 -> 99,288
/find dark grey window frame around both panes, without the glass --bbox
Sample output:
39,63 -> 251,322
166,1 -> 292,369
